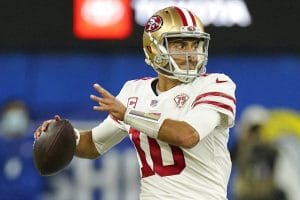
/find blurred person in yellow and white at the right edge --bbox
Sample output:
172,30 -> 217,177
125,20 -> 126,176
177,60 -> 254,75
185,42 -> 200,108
261,109 -> 300,200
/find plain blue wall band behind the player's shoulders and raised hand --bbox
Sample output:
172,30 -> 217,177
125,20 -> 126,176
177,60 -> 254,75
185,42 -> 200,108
0,54 -> 300,119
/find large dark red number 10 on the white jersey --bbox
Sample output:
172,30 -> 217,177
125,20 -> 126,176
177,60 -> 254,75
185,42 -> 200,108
129,128 -> 185,178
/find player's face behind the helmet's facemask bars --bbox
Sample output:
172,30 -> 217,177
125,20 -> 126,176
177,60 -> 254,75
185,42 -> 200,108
168,38 -> 203,70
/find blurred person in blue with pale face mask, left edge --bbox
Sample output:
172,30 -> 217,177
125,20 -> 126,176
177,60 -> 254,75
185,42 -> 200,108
0,100 -> 43,200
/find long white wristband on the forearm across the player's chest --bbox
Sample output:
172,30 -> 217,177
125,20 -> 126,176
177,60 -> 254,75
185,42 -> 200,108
124,108 -> 163,138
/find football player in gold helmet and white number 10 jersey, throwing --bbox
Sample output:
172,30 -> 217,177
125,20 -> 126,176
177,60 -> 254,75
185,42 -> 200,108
35,7 -> 236,200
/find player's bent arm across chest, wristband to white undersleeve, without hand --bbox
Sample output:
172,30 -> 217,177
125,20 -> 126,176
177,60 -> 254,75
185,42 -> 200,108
124,107 -> 221,148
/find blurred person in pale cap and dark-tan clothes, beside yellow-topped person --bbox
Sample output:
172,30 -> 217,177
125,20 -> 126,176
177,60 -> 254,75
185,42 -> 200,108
232,105 -> 286,200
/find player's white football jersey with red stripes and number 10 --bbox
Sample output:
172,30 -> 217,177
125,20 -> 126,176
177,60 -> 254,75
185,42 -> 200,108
92,74 -> 236,200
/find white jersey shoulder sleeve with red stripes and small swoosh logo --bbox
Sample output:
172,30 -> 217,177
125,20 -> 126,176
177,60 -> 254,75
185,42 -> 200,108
191,74 -> 236,127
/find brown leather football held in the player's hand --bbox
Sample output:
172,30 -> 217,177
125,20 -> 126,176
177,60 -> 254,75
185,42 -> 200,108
33,120 -> 76,176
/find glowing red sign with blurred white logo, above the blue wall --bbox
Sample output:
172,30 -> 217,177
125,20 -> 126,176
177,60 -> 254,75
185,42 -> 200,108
73,0 -> 133,39
